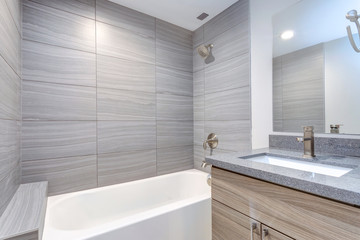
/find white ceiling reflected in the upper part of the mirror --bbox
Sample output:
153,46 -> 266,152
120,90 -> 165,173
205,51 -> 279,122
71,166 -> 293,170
273,0 -> 360,57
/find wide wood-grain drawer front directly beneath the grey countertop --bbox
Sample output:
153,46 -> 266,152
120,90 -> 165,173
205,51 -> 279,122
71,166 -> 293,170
212,167 -> 360,240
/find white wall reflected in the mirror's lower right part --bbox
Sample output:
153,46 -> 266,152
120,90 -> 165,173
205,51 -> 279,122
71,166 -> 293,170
325,36 -> 360,134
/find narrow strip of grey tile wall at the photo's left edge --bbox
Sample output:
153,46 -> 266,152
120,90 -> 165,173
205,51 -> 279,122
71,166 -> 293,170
0,0 -> 21,216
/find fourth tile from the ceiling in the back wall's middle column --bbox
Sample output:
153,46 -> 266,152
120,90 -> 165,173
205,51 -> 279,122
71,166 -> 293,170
97,88 -> 156,120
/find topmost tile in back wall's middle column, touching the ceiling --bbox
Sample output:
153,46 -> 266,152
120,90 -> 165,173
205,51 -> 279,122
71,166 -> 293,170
96,0 -> 155,37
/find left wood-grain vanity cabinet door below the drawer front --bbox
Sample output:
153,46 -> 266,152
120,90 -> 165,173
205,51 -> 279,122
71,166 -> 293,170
212,200 -> 261,240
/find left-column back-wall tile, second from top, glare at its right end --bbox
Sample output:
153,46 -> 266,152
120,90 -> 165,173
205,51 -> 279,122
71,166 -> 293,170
23,0 -> 95,52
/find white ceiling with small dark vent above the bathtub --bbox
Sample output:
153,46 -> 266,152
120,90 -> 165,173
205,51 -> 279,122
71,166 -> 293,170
110,0 -> 238,31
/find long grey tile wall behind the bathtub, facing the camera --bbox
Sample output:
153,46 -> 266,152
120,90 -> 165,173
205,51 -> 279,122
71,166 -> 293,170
19,0 -> 193,195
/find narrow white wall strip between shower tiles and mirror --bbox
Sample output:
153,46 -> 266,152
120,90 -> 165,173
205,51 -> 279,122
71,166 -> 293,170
250,0 -> 299,149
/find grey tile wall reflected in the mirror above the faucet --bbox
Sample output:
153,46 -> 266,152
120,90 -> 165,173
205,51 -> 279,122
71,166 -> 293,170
273,44 -> 325,133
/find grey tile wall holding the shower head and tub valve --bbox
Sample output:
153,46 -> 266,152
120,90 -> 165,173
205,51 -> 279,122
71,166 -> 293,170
193,0 -> 251,171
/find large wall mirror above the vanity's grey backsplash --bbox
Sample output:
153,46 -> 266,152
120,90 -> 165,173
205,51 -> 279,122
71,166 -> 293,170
273,0 -> 360,134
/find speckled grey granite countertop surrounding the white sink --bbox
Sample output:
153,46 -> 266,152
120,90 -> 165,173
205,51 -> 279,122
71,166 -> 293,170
206,148 -> 360,207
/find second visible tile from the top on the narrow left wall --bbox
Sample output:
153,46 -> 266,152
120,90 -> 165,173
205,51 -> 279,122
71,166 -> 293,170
0,0 -> 21,75
